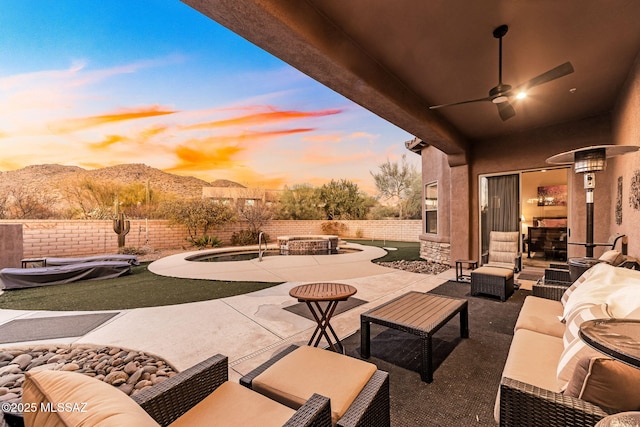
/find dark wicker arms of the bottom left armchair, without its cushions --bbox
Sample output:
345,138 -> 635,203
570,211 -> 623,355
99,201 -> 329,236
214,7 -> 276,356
5,354 -> 331,427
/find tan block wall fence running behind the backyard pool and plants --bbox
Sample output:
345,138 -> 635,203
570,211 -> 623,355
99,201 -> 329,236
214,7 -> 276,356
0,219 -> 422,258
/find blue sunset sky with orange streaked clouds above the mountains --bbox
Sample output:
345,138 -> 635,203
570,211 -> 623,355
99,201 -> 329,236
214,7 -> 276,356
0,0 -> 419,193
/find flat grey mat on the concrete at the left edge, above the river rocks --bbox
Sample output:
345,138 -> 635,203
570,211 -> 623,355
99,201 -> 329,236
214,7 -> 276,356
0,312 -> 119,344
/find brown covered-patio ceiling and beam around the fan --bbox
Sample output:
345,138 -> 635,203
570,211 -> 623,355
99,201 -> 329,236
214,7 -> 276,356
183,0 -> 640,162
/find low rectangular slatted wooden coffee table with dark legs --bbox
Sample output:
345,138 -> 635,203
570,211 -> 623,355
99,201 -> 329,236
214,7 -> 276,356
360,292 -> 469,383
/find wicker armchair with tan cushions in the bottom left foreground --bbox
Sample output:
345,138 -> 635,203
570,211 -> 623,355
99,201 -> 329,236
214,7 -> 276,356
5,354 -> 331,427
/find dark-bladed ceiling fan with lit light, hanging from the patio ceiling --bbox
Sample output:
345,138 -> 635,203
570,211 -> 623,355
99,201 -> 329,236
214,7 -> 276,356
429,25 -> 573,121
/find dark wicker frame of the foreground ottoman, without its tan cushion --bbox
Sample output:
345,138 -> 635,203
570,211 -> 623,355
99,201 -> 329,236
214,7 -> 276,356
240,345 -> 391,427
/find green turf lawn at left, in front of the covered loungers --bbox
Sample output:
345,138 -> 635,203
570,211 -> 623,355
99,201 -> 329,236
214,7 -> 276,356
0,263 -> 279,311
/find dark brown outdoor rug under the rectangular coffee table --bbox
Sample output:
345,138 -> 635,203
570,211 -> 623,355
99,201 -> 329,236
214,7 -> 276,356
342,281 -> 531,427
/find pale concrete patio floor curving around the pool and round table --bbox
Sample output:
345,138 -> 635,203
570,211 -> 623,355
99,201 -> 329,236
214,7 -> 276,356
0,245 -> 455,381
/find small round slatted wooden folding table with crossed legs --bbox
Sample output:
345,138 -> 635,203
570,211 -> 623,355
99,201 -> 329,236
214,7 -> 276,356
289,283 -> 358,353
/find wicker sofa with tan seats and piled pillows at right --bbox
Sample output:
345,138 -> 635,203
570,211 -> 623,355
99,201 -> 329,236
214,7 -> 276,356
494,264 -> 640,427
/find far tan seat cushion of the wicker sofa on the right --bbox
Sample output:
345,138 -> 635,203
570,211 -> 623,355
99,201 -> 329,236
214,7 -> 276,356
514,296 -> 565,338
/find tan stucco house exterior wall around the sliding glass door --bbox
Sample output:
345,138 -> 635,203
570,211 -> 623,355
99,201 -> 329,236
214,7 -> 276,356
420,47 -> 640,265
